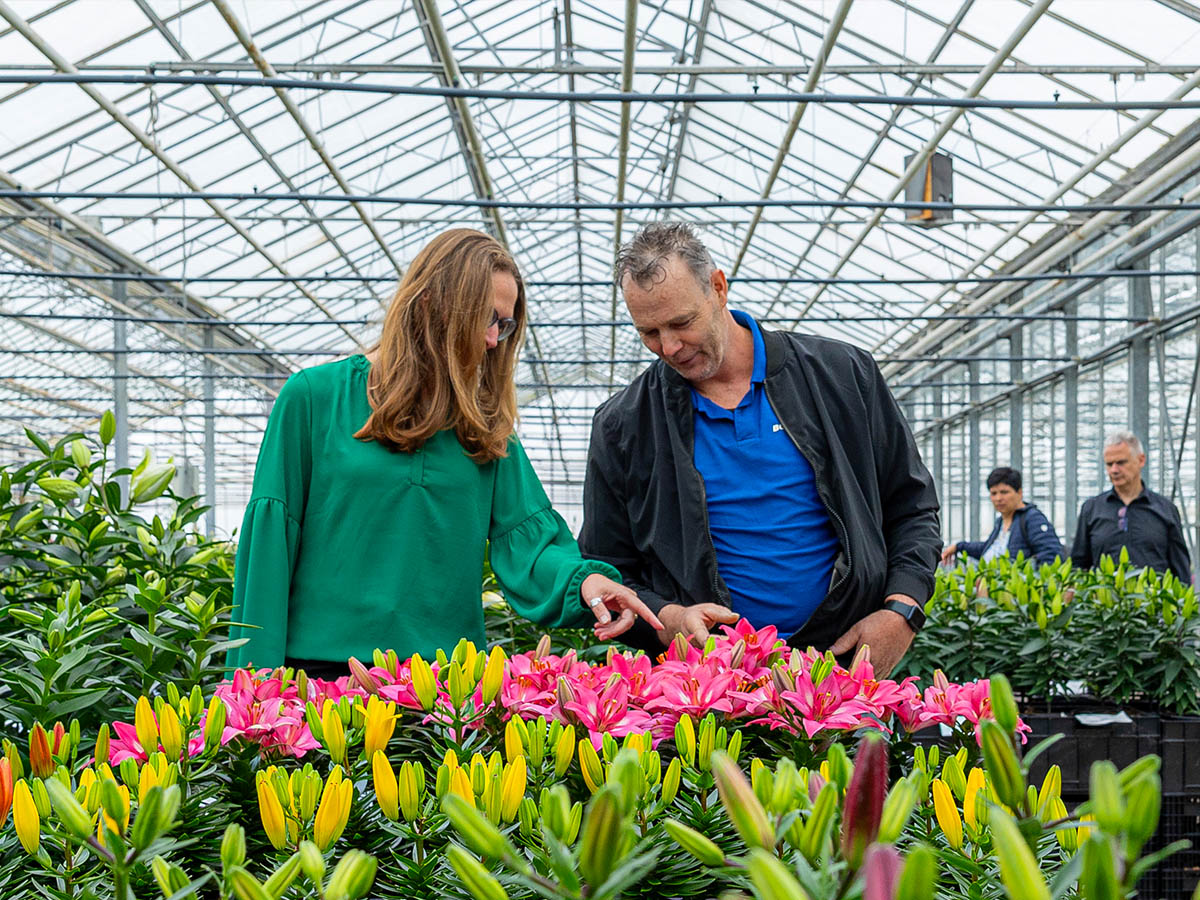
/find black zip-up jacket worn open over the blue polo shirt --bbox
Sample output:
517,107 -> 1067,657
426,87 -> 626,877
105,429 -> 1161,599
580,329 -> 942,652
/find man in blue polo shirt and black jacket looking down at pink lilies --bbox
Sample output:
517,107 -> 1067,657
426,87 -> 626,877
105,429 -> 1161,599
580,223 -> 941,674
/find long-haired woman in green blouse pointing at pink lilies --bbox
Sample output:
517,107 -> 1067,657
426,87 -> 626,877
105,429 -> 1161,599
228,229 -> 662,674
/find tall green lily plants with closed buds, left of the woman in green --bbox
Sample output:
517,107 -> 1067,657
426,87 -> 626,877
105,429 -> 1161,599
0,414 -> 233,738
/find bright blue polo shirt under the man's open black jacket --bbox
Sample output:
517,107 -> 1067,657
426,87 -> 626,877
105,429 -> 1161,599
691,311 -> 839,637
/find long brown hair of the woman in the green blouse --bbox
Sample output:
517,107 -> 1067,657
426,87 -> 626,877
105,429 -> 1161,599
354,228 -> 526,463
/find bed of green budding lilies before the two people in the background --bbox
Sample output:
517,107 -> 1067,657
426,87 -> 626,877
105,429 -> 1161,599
893,557 -> 1200,715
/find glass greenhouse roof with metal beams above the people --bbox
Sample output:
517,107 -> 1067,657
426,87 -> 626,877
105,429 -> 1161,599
0,0 -> 1200,527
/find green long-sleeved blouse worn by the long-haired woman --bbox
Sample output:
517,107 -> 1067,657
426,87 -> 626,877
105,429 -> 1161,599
228,355 -> 619,667
